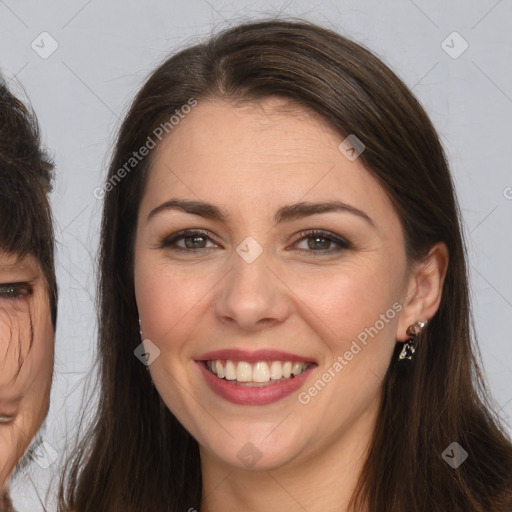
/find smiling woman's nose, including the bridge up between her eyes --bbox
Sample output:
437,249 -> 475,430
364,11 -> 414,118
215,237 -> 288,330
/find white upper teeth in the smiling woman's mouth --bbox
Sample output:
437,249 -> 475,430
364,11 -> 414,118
206,359 -> 309,382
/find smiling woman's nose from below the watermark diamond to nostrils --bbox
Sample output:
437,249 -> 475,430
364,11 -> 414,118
214,248 -> 291,331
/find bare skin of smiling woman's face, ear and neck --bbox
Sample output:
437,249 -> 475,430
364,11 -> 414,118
134,98 -> 448,512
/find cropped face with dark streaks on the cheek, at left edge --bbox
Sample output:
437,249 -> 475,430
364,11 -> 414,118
0,252 -> 53,491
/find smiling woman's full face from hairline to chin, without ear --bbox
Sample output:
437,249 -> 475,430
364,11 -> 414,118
135,99 -> 407,469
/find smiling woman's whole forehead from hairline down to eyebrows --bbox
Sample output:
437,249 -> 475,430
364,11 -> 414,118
141,98 -> 394,226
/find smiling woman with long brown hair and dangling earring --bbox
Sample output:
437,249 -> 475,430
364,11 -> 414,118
61,21 -> 512,512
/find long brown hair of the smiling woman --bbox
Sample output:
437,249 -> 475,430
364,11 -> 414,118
60,20 -> 512,512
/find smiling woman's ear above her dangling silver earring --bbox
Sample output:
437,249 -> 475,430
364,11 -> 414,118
396,242 -> 449,341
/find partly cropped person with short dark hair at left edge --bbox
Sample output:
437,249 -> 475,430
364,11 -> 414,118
0,83 -> 57,511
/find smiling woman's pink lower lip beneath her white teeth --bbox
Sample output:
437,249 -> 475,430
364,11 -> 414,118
197,361 -> 315,405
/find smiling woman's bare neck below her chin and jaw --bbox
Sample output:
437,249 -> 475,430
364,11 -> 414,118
201,404 -> 378,512
